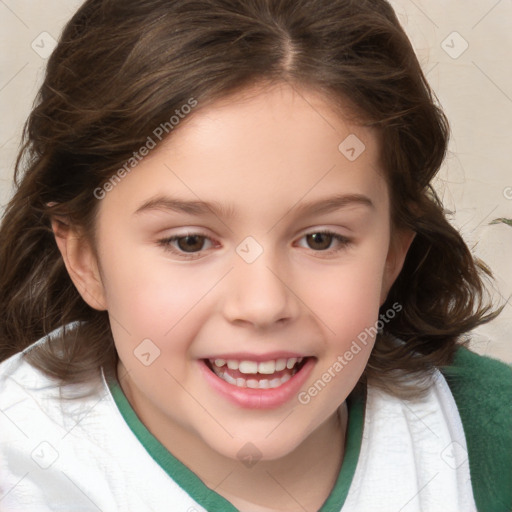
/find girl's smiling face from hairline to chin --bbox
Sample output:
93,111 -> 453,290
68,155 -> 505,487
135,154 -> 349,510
77,85 -> 409,459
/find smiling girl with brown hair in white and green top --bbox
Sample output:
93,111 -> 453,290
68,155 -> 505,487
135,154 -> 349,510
0,0 -> 512,512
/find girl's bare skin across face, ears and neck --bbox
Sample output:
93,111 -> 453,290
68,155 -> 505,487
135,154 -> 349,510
54,84 -> 413,511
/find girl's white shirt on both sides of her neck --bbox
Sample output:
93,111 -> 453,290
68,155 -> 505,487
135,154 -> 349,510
0,334 -> 476,512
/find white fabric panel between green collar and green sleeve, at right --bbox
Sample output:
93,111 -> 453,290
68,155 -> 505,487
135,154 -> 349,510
343,371 -> 477,512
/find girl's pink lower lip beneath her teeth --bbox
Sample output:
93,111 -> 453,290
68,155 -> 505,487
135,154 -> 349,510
198,354 -> 316,409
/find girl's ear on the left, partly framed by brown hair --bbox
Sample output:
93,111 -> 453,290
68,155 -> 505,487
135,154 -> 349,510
51,217 -> 107,311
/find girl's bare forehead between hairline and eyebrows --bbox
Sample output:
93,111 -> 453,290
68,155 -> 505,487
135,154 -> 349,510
102,84 -> 387,222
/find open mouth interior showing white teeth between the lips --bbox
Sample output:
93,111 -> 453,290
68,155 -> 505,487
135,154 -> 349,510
204,357 -> 311,389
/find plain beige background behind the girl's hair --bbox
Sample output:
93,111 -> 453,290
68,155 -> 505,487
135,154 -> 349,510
0,0 -> 512,362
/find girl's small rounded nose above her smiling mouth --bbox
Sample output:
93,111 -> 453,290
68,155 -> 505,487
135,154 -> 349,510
223,248 -> 299,329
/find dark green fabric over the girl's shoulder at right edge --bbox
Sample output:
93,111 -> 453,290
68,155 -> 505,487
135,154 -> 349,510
439,346 -> 512,512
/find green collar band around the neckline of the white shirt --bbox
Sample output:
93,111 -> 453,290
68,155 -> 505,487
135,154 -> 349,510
107,379 -> 365,512
